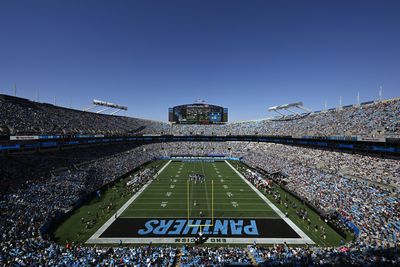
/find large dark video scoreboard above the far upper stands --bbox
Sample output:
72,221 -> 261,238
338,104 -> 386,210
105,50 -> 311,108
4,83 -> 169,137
168,103 -> 228,124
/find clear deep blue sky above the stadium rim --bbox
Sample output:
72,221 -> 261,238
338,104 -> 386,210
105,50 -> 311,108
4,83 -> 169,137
0,0 -> 400,121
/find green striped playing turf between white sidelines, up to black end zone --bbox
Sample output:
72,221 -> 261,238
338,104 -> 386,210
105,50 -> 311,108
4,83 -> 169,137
121,161 -> 279,218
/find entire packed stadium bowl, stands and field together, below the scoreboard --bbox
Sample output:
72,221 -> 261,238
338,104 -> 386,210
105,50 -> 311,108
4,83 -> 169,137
0,95 -> 400,266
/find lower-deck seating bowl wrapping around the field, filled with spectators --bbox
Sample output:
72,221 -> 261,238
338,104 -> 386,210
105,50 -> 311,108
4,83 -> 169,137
1,142 -> 399,266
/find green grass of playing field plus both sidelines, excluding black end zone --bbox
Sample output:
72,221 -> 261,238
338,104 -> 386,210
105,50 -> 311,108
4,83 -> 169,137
54,160 -> 351,246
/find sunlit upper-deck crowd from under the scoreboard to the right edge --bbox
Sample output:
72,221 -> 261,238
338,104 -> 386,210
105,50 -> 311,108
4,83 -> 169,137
171,99 -> 400,136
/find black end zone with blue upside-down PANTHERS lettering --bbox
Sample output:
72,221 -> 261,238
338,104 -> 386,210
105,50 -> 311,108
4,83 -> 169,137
100,218 -> 300,238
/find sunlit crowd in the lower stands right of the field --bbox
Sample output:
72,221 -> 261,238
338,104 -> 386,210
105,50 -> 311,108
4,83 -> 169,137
239,143 -> 400,248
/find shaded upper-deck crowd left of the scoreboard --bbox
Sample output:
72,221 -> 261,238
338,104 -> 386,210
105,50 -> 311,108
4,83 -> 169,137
0,95 -> 168,136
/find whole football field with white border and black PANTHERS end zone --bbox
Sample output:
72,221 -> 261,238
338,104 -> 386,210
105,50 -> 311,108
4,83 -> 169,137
87,160 -> 313,244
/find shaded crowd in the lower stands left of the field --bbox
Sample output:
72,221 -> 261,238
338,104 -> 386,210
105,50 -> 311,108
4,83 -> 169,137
0,147 -> 155,243
